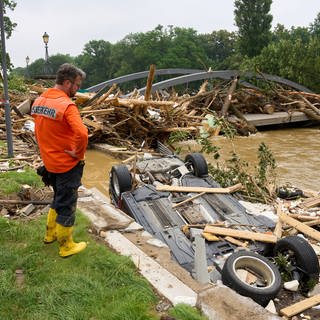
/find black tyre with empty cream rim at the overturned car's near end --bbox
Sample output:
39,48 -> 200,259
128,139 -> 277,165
221,251 -> 281,306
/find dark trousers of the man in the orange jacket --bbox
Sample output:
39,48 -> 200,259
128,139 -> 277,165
49,161 -> 84,227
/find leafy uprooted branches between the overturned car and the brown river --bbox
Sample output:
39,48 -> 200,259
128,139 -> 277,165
209,143 -> 276,203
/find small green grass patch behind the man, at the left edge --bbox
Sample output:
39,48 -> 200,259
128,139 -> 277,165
0,167 -> 43,195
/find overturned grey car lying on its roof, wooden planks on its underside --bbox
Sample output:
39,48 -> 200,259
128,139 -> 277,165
109,144 -> 319,306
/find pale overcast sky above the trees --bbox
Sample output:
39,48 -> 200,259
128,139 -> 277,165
6,0 -> 320,67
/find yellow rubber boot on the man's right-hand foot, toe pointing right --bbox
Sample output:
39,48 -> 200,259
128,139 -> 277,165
57,224 -> 87,257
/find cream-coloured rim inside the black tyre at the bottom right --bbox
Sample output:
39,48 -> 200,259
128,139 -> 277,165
232,256 -> 275,289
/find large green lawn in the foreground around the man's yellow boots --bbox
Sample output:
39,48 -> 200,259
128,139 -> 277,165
0,214 -> 205,320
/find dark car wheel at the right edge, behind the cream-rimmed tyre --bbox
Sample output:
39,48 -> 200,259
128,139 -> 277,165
274,236 -> 319,291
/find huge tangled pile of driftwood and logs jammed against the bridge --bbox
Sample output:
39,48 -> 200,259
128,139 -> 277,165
0,78 -> 320,150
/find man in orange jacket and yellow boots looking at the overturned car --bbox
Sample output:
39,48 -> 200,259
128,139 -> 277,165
31,63 -> 88,257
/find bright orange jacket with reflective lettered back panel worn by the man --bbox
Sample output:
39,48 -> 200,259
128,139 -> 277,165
31,88 -> 88,173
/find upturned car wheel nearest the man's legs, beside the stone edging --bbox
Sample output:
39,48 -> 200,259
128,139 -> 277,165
110,165 -> 132,203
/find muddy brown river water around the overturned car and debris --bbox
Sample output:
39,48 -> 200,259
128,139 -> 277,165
82,127 -> 320,194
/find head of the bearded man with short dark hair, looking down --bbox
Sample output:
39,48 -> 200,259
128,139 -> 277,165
56,63 -> 86,97
